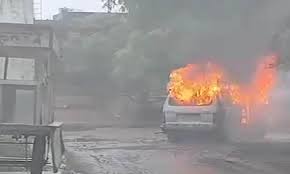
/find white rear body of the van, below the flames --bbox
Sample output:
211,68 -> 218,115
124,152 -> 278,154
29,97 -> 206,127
161,96 -> 225,140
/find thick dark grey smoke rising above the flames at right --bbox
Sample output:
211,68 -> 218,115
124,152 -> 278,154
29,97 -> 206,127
177,0 -> 290,83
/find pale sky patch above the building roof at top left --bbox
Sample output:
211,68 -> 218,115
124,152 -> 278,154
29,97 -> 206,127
42,0 -> 104,19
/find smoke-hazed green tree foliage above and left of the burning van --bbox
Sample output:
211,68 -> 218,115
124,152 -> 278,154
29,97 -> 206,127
108,0 -> 260,94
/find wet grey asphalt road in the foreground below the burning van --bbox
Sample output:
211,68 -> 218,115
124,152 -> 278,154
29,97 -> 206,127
61,128 -> 290,174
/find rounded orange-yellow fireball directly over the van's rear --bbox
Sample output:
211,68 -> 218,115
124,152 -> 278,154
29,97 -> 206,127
168,63 -> 223,105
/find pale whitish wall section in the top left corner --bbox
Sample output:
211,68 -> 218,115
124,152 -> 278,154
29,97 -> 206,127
0,0 -> 33,24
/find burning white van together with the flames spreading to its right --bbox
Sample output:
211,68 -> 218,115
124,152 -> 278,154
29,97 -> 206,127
161,55 -> 278,142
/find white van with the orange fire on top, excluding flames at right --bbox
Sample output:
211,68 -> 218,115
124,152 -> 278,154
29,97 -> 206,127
161,63 -> 225,140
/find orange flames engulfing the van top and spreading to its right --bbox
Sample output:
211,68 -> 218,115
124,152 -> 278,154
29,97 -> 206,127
168,55 -> 278,108
